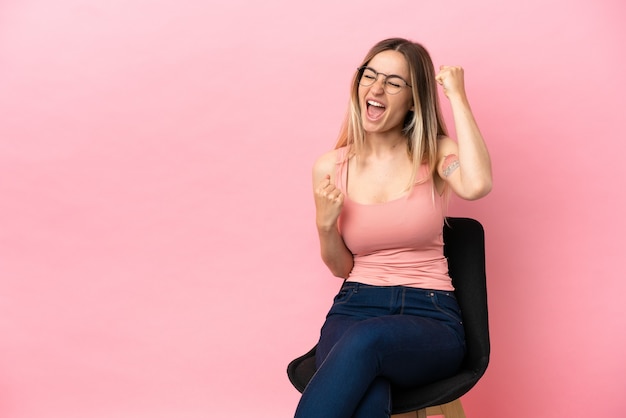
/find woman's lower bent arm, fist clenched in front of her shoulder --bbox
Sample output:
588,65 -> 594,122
313,151 -> 354,279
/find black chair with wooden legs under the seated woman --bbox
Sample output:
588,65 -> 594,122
287,218 -> 490,418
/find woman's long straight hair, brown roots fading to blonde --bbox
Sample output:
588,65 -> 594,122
335,38 -> 447,188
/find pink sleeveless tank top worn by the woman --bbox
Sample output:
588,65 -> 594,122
335,147 -> 454,290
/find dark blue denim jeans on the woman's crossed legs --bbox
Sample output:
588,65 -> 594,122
295,282 -> 465,418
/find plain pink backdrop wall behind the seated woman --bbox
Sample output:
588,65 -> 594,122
0,0 -> 626,418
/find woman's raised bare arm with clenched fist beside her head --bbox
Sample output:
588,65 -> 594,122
436,65 -> 492,200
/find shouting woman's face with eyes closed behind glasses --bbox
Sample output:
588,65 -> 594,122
358,50 -> 413,133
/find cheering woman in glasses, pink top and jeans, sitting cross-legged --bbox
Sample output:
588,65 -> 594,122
296,38 -> 491,418
